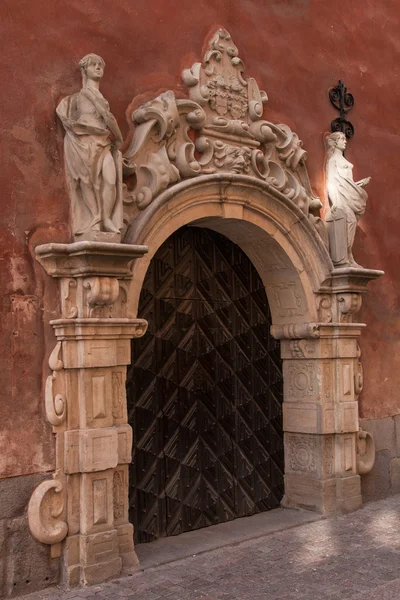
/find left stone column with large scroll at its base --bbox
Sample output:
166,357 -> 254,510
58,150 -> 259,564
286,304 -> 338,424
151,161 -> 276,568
28,242 -> 147,586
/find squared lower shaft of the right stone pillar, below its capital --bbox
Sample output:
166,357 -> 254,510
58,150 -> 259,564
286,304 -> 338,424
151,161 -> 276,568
281,323 -> 362,512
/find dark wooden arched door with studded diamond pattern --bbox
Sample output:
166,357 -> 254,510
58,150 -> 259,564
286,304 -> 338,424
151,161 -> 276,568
127,227 -> 283,542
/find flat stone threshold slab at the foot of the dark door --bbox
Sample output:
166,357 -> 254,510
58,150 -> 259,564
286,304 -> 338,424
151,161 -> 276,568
128,508 -> 326,577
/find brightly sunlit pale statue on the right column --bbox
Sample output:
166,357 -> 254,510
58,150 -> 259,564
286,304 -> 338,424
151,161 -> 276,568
326,132 -> 371,267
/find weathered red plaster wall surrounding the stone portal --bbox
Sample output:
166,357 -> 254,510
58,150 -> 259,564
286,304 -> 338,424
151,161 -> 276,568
0,0 -> 400,476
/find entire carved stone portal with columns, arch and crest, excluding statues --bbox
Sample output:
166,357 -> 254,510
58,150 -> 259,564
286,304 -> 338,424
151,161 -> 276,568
29,30 -> 382,585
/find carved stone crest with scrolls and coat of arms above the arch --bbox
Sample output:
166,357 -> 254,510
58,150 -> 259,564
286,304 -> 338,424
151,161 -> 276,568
124,29 -> 326,239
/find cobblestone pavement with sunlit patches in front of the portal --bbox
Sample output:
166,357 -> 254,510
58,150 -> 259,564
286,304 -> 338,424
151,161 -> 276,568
24,496 -> 400,600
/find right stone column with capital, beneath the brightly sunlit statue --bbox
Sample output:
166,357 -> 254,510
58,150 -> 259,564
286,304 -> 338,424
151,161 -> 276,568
272,269 -> 381,513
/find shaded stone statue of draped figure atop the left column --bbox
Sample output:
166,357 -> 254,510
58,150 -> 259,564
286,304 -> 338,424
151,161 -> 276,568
57,54 -> 123,241
